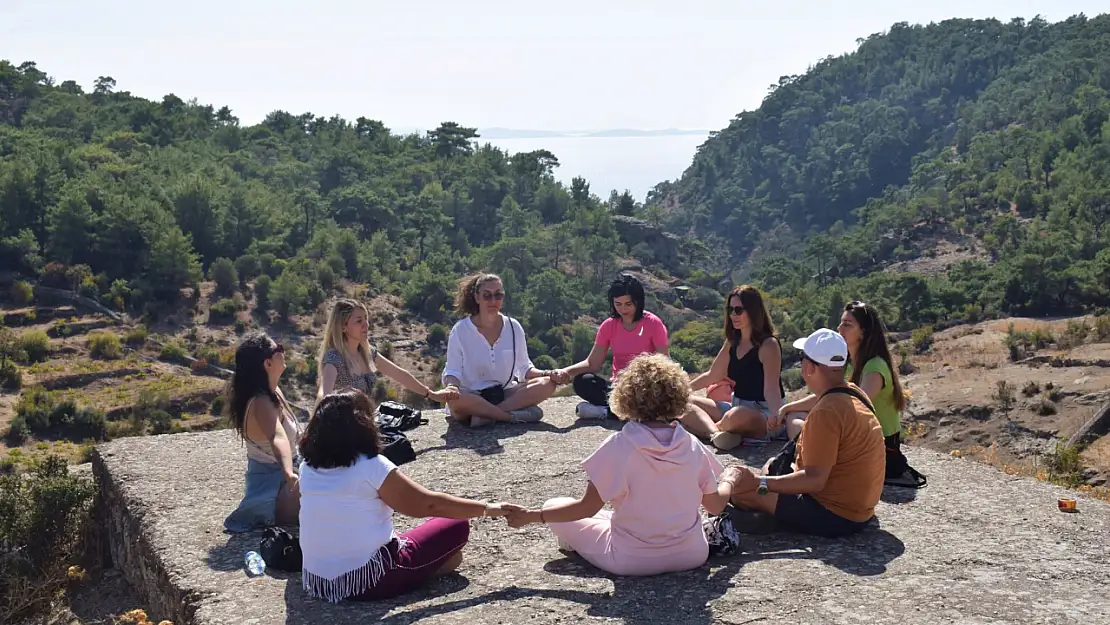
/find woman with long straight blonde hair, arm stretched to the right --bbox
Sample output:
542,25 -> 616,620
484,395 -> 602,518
316,299 -> 458,403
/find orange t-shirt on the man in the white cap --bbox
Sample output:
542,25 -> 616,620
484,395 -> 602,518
797,384 -> 887,523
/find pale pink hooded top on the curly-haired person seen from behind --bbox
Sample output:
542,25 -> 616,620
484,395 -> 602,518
582,421 -> 723,557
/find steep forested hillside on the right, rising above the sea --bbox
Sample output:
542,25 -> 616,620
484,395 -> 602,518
644,14 -> 1110,329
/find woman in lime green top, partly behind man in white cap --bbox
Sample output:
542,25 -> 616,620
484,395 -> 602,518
775,301 -> 906,439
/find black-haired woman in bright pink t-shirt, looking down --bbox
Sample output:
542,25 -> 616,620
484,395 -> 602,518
552,273 -> 668,419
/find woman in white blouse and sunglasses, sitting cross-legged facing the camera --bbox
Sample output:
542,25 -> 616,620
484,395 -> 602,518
443,273 -> 555,427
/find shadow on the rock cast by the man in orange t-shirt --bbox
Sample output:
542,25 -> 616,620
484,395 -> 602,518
741,528 -> 906,576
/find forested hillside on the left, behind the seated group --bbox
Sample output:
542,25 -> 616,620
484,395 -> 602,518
0,61 -> 737,360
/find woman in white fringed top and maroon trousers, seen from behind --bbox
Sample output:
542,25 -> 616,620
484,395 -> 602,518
300,390 -> 524,603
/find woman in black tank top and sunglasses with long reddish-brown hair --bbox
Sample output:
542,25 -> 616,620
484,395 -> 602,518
683,284 -> 786,450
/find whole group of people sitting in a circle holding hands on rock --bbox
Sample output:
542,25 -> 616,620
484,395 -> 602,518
224,274 -> 906,602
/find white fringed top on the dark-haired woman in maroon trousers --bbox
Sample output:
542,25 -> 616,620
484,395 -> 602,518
300,455 -> 396,579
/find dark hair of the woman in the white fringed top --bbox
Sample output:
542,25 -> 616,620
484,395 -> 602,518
297,390 -> 382,468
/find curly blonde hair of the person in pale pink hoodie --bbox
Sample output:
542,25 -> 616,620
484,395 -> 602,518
609,354 -> 690,421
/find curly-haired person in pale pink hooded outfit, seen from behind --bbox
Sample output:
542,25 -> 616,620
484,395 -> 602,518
507,354 -> 736,575
